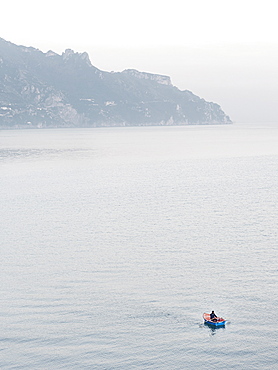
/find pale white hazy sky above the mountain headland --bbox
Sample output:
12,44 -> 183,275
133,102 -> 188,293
0,0 -> 278,122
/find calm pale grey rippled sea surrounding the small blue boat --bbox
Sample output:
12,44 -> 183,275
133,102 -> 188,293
0,124 -> 278,370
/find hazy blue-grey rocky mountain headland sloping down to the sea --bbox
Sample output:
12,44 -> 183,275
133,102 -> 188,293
0,39 -> 231,127
